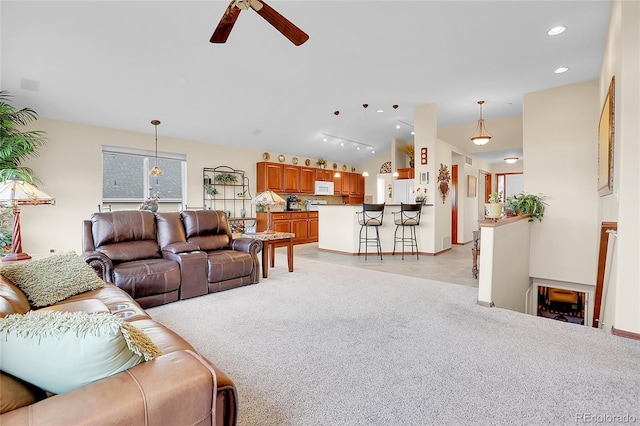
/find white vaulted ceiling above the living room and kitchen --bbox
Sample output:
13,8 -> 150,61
0,0 -> 611,165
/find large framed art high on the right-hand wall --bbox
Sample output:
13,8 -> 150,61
598,77 -> 616,197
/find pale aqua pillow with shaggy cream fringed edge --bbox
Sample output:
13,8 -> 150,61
0,311 -> 161,394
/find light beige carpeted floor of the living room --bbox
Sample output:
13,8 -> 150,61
148,254 -> 640,426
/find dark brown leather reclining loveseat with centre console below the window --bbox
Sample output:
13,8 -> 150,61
82,210 -> 262,308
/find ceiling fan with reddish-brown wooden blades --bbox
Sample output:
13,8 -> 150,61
209,0 -> 309,46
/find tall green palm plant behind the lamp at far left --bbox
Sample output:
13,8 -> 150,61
0,91 -> 46,184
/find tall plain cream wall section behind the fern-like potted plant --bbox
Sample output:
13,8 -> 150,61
523,80 -> 600,285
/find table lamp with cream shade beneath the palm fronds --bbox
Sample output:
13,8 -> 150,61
0,179 -> 56,262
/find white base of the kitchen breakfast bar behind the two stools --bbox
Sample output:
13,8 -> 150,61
318,204 -> 433,255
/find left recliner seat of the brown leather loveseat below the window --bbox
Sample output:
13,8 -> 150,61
83,210 -> 181,308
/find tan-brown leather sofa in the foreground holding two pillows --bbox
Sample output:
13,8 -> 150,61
0,276 -> 237,426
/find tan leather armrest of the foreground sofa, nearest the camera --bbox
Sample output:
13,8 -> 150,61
0,350 -> 217,425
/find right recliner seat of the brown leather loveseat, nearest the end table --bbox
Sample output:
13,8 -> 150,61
161,210 -> 262,293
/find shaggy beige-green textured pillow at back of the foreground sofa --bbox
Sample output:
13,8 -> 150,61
0,253 -> 104,307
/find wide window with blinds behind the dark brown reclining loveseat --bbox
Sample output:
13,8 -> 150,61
102,145 -> 187,203
